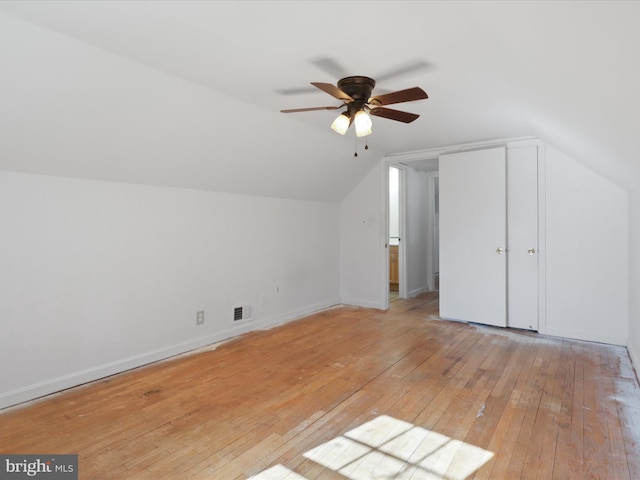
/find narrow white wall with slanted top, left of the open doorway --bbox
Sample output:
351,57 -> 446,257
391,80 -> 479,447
340,162 -> 389,308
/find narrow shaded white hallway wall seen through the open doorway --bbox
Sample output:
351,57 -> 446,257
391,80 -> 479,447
403,168 -> 429,297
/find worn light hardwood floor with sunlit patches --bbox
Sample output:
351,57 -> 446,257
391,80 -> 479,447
0,294 -> 640,480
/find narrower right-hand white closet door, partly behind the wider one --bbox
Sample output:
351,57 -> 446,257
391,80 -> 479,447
507,145 -> 538,330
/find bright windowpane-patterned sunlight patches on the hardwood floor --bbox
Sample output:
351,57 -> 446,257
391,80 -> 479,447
251,415 -> 493,480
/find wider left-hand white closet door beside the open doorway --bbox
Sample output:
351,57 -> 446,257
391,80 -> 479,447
439,148 -> 507,327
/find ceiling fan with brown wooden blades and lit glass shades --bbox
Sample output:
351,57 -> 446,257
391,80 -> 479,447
280,76 -> 429,137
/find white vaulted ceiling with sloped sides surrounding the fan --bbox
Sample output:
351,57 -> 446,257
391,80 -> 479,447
0,0 -> 640,202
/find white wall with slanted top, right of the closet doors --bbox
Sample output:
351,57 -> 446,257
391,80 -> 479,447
545,145 -> 629,345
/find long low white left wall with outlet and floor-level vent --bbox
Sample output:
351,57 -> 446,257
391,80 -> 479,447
0,172 -> 339,407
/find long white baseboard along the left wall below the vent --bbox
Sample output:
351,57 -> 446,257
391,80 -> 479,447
0,299 -> 340,409
